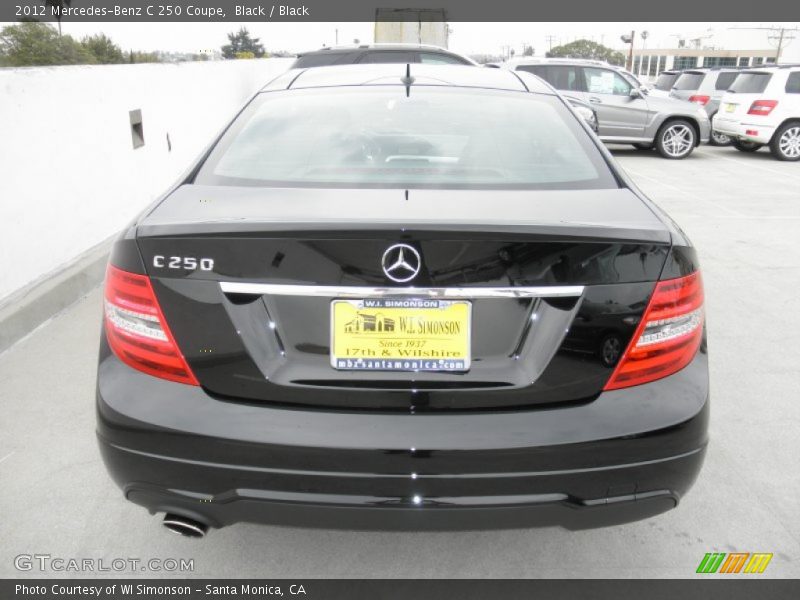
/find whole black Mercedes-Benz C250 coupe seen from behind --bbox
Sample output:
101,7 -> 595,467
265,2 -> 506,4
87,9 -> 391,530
97,64 -> 709,536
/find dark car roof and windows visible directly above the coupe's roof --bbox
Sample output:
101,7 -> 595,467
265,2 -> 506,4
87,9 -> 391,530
292,44 -> 478,69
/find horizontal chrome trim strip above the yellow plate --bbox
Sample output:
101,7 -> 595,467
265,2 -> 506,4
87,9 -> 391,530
219,281 -> 584,299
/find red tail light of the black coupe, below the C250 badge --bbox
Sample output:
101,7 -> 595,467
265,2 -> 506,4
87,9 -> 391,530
105,265 -> 199,385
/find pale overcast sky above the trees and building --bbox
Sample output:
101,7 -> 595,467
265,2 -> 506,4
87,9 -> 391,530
14,21 -> 800,62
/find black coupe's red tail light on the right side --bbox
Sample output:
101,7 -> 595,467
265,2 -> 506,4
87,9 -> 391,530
604,272 -> 704,390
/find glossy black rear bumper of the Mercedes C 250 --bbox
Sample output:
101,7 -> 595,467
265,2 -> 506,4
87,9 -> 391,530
97,353 -> 708,529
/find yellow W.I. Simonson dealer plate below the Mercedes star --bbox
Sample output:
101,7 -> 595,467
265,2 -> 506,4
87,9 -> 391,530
331,298 -> 472,371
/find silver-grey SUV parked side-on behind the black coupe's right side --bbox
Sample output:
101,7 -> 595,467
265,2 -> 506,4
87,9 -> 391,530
509,59 -> 711,159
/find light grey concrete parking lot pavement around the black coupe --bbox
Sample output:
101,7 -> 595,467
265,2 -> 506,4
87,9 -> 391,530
0,147 -> 800,578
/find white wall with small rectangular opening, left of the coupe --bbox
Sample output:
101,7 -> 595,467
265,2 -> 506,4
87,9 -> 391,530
0,59 -> 290,304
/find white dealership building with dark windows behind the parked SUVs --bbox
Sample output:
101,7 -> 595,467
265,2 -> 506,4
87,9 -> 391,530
632,48 -> 775,78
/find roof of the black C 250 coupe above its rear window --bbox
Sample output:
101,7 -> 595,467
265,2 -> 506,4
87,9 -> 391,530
261,63 -> 555,95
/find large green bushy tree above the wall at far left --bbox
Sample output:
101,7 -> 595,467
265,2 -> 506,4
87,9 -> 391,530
0,21 -> 97,67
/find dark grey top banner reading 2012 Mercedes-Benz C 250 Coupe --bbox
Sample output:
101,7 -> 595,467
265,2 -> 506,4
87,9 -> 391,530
0,0 -> 800,23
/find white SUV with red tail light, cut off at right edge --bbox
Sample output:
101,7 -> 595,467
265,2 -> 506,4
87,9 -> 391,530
712,66 -> 800,160
